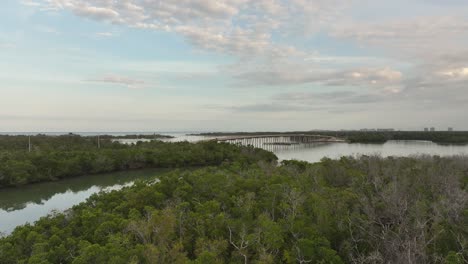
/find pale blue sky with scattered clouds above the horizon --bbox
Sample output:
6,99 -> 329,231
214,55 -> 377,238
0,0 -> 468,132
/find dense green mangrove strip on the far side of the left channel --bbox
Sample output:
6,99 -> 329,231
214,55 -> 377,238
0,135 -> 276,188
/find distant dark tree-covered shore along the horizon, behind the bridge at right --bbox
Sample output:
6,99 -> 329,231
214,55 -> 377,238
193,130 -> 468,144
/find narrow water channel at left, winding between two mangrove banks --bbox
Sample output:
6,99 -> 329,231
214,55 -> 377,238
0,169 -> 167,234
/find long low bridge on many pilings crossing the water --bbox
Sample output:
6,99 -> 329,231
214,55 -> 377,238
209,133 -> 346,150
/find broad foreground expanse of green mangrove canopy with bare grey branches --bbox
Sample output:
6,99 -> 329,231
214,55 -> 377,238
0,157 -> 468,264
